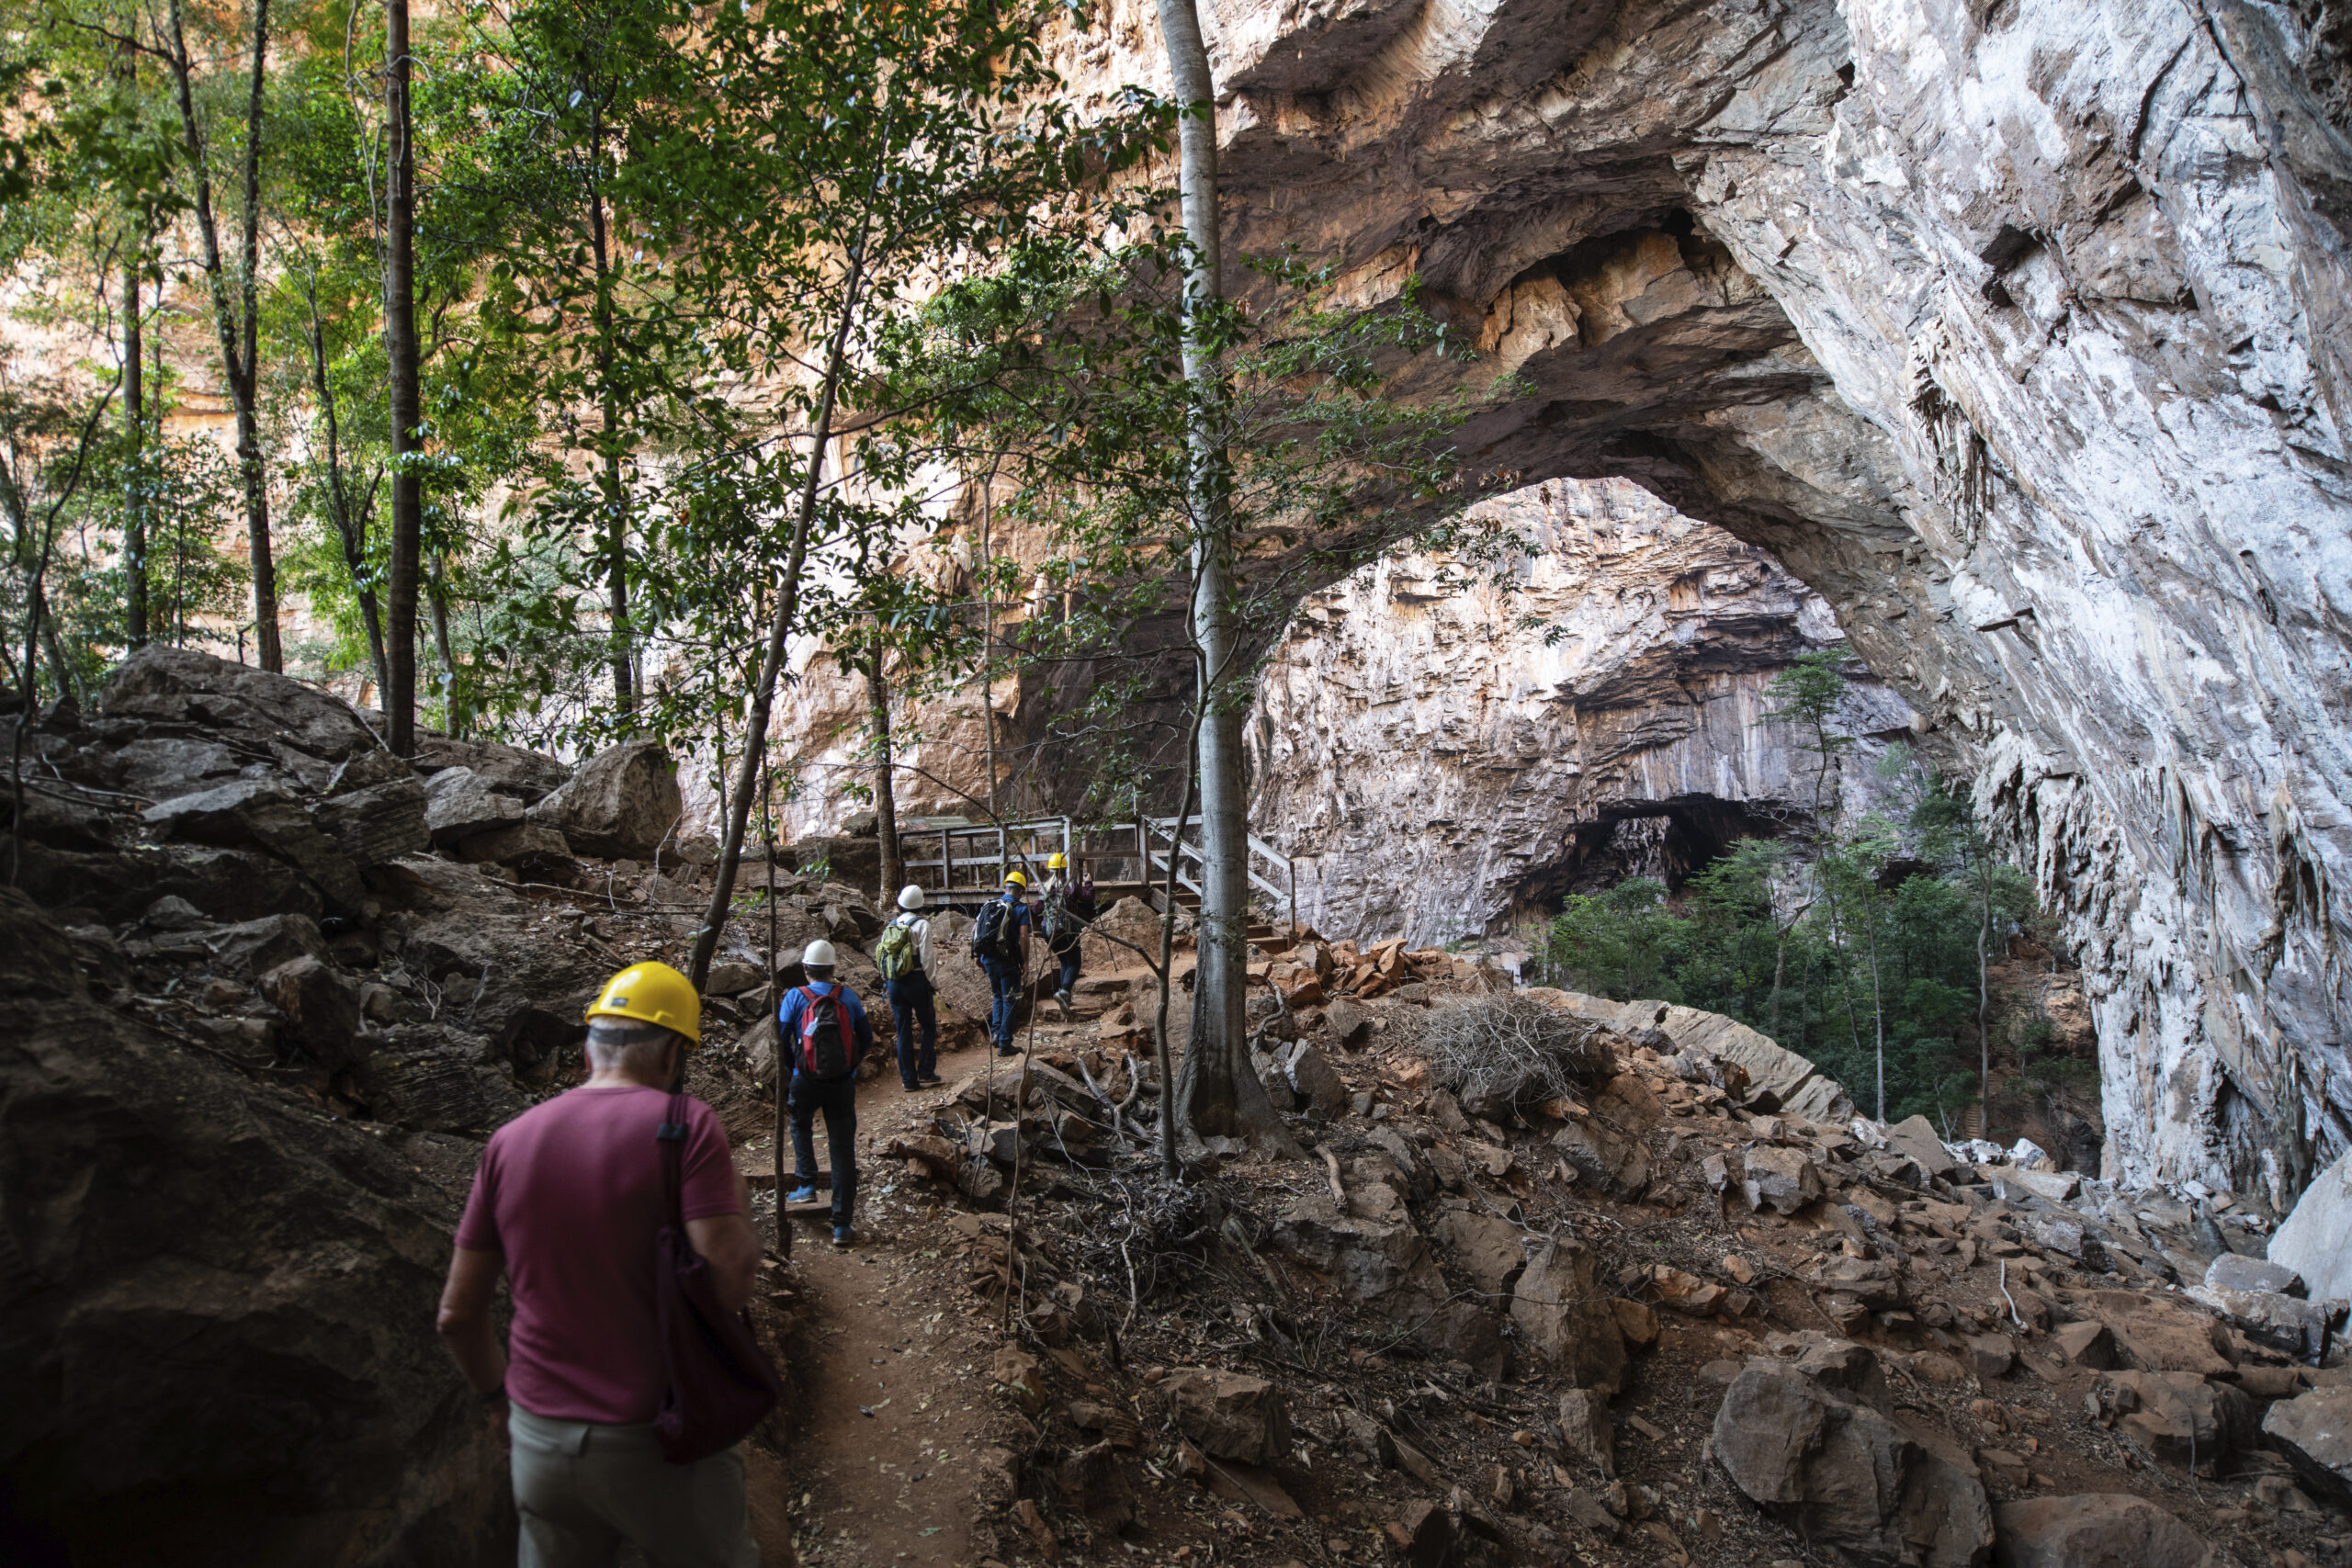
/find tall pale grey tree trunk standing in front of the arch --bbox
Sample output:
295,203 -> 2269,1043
1159,0 -> 1289,1145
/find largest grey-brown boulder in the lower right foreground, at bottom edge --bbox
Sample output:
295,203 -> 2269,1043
1714,1340 -> 1992,1568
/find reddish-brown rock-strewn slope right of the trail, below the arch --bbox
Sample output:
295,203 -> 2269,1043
879,936 -> 2352,1568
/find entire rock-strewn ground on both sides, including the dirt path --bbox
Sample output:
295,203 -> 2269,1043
0,649 -> 2352,1568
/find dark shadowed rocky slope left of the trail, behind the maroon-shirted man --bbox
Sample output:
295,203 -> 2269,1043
0,649 -> 917,1568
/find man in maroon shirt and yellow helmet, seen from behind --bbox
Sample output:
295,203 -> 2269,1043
437,964 -> 760,1568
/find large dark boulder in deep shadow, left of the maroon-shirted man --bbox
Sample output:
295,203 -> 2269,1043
0,894 -> 513,1568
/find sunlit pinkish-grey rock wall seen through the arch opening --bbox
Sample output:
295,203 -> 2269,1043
1247,479 -> 1912,945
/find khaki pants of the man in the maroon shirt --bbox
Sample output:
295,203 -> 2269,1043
508,1405 -> 760,1568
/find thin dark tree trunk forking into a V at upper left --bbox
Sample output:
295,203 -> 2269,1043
167,0 -> 277,672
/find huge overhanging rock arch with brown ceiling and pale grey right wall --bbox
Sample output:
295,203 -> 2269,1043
1044,0 -> 2352,1190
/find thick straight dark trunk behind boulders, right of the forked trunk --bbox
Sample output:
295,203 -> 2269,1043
383,0 -> 424,757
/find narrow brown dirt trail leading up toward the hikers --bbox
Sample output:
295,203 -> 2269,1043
746,1048 -> 1030,1568
